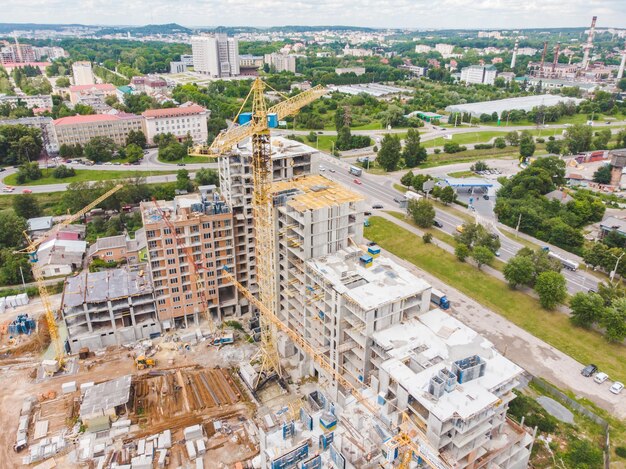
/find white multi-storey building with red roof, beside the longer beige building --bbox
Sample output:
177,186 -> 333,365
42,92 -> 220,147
141,102 -> 211,144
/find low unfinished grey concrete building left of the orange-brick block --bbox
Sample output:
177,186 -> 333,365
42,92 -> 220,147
61,266 -> 161,353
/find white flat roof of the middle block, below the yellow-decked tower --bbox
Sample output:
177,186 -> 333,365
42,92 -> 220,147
307,247 -> 430,311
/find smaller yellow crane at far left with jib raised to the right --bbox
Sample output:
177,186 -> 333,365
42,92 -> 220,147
16,184 -> 124,368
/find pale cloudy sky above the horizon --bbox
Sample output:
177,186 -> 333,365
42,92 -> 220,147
0,0 -> 626,29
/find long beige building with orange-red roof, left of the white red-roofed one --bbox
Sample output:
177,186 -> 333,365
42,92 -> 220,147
52,112 -> 144,145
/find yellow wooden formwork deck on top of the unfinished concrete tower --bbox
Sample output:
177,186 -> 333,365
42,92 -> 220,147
272,175 -> 363,212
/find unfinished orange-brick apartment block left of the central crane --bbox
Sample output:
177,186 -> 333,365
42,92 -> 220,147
141,186 -> 238,329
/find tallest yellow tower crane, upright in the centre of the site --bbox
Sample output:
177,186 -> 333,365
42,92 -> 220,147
189,78 -> 326,388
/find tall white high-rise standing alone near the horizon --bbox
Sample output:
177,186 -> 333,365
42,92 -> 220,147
191,33 -> 239,78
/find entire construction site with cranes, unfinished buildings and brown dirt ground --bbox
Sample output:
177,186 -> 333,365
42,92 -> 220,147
0,79 -> 534,469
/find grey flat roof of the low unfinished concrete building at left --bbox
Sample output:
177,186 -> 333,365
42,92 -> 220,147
61,268 -> 152,308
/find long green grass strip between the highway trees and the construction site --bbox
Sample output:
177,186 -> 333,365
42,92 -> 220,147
365,216 -> 626,382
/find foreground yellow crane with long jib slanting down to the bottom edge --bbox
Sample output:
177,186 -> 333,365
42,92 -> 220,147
223,267 -> 451,469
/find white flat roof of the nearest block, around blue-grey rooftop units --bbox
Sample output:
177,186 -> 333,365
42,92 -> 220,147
374,309 -> 523,421
